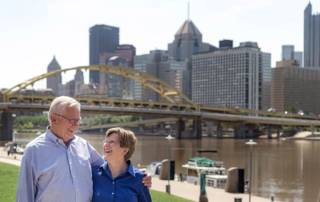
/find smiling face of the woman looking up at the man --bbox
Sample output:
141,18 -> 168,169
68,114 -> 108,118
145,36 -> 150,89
103,133 -> 129,161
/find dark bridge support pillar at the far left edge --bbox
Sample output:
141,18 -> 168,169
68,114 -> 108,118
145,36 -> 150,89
0,112 -> 14,142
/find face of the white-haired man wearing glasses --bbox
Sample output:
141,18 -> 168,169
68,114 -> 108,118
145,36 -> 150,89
51,106 -> 81,142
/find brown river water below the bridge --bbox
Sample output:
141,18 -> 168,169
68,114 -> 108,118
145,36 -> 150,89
16,134 -> 320,202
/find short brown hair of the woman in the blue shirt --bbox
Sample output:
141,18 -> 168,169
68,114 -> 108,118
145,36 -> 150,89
106,127 -> 137,161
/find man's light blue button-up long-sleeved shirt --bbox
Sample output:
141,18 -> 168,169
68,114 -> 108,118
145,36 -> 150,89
16,129 -> 103,202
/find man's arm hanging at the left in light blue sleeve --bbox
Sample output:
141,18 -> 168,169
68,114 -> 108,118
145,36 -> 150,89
16,148 -> 36,202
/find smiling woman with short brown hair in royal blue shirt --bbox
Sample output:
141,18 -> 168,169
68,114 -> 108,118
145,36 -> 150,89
92,128 -> 151,202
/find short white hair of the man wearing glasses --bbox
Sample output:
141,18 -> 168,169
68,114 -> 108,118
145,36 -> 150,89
48,96 -> 80,125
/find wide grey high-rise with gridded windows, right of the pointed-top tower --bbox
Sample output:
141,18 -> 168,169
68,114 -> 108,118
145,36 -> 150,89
192,42 -> 271,110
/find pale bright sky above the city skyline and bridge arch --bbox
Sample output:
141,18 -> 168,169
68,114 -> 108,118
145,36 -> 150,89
0,0 -> 320,88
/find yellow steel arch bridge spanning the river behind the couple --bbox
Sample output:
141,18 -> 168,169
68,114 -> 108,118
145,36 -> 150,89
0,65 -> 320,140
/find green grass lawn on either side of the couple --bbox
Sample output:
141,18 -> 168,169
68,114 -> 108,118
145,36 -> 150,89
0,163 -> 191,202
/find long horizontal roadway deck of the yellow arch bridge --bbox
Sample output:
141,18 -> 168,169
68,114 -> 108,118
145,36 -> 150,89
0,103 -> 320,127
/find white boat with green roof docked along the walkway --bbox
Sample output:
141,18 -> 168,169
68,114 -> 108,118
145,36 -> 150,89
182,157 -> 228,188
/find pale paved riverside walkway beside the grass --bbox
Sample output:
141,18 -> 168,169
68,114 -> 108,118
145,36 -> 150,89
0,147 -> 270,202
